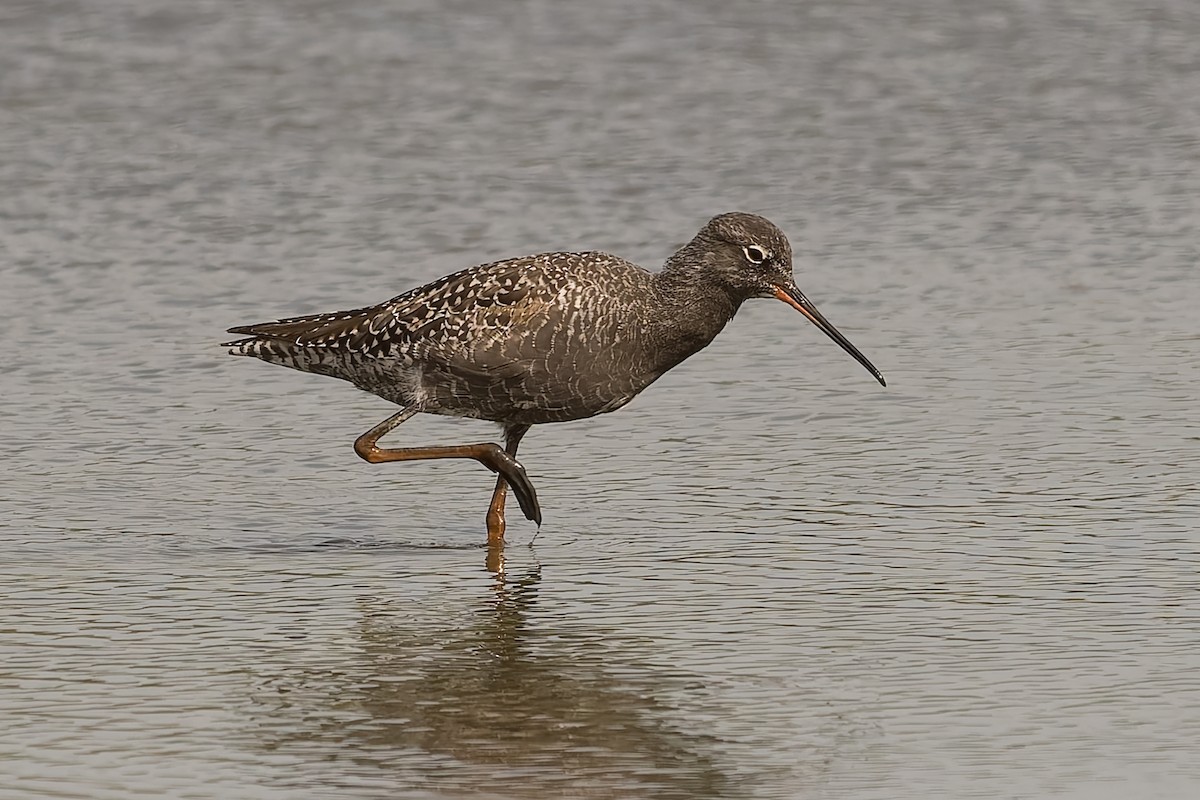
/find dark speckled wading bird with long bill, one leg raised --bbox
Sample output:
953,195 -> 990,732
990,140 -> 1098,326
226,213 -> 887,545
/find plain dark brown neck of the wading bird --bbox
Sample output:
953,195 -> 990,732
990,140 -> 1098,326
649,261 -> 744,371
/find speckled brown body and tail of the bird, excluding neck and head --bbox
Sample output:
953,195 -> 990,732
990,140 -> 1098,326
229,252 -> 658,423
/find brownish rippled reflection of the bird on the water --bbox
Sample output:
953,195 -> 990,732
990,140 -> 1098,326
255,554 -> 736,799
